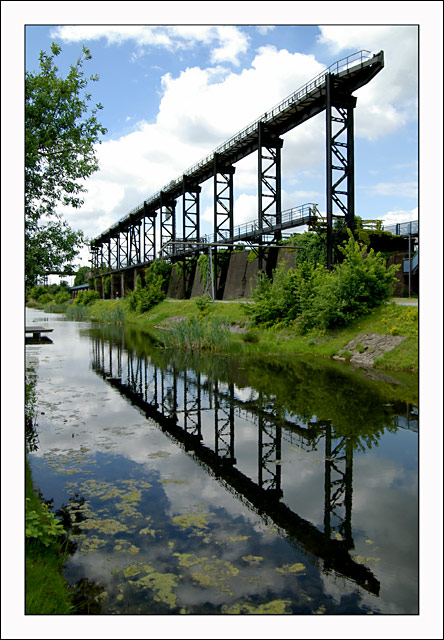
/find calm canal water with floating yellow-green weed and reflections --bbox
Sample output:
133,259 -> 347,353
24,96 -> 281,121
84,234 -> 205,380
26,309 -> 418,615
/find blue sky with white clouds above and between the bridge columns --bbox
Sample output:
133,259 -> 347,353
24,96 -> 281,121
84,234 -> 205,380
25,24 -> 418,260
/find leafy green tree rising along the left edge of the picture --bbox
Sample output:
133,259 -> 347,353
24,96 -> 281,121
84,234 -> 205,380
25,43 -> 106,286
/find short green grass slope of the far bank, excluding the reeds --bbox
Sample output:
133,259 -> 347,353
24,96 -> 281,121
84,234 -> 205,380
35,298 -> 418,372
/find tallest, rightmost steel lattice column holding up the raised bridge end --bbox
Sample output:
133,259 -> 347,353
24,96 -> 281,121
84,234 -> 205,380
325,74 -> 356,269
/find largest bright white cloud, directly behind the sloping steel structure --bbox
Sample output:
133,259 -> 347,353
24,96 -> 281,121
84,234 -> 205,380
72,47 -> 324,237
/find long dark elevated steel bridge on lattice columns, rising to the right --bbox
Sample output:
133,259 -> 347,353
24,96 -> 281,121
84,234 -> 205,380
90,50 -> 384,288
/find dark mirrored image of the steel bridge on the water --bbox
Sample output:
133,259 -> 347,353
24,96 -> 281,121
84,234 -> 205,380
92,337 -> 379,594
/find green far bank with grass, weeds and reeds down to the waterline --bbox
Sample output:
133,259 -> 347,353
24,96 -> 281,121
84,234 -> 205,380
30,298 -> 418,372
